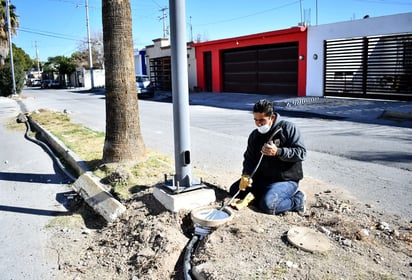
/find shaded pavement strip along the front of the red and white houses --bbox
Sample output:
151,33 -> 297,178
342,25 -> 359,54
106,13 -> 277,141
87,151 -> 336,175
153,92 -> 412,127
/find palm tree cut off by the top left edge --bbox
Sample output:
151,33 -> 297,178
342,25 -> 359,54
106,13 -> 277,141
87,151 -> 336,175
0,0 -> 19,65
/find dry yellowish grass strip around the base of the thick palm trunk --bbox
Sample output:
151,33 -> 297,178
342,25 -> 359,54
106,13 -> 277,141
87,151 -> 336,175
30,110 -> 173,198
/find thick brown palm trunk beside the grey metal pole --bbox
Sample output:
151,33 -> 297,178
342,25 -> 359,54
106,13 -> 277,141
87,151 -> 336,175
102,0 -> 146,163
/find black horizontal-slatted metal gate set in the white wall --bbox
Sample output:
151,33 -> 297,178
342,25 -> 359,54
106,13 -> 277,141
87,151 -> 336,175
324,33 -> 412,100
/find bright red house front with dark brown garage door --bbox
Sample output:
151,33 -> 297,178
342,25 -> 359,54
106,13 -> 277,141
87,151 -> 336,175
193,27 -> 307,96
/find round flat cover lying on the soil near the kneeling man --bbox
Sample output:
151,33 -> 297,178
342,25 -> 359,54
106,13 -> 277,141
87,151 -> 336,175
287,227 -> 332,252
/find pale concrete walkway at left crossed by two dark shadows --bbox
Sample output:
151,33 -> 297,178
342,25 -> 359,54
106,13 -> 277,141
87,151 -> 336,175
0,97 -> 72,280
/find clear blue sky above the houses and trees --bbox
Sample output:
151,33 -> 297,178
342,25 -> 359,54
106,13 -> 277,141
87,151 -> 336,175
10,0 -> 412,61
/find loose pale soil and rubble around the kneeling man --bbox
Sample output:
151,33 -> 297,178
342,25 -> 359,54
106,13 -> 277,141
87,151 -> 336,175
48,173 -> 412,280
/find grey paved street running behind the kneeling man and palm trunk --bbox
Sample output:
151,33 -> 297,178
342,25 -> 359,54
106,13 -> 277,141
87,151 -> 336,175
16,88 -> 412,218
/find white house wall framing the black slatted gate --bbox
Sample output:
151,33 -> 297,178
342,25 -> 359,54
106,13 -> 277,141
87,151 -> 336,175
306,13 -> 412,96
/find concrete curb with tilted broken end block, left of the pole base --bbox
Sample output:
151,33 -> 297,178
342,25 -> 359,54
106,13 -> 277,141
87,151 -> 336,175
29,118 -> 126,223
